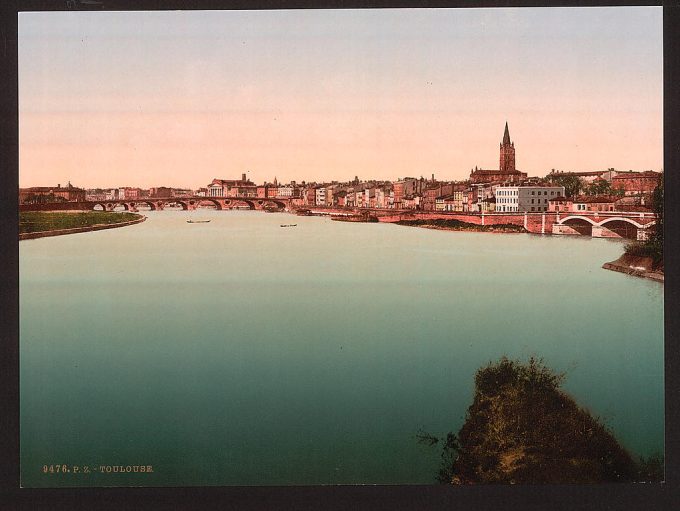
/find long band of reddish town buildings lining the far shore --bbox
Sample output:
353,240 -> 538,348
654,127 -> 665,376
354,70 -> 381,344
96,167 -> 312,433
20,169 -> 661,213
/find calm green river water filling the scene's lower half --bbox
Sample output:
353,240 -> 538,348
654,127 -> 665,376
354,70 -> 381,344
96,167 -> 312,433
19,210 -> 664,487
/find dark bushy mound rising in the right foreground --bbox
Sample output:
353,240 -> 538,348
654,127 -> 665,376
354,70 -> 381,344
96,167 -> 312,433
419,358 -> 663,484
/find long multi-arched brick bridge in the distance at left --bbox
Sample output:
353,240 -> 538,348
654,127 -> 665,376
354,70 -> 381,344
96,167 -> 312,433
20,197 -> 291,211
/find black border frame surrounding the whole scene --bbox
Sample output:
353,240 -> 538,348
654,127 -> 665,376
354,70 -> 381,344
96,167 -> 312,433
0,0 -> 680,510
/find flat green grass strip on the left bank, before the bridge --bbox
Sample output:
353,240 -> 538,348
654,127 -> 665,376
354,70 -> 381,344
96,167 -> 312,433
19,211 -> 141,234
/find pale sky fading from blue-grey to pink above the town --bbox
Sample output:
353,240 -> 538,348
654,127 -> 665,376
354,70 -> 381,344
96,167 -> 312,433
19,7 -> 663,189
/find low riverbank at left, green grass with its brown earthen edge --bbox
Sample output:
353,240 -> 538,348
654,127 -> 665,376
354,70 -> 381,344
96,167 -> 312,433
19,211 -> 146,241
